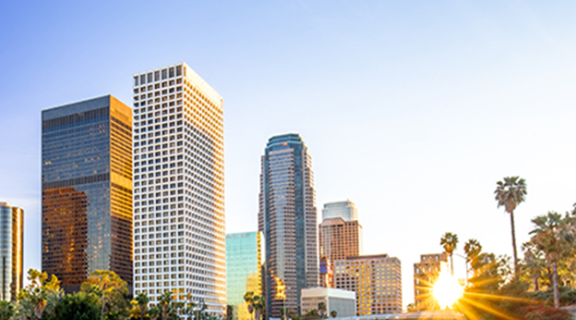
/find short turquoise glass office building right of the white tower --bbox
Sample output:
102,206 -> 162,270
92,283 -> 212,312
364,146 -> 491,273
226,232 -> 264,320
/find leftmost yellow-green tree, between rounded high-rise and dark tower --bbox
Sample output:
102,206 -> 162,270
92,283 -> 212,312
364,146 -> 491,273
16,269 -> 64,320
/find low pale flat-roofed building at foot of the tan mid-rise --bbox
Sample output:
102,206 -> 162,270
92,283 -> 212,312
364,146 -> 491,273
300,288 -> 356,318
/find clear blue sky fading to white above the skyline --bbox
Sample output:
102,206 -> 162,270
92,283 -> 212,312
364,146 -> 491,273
0,0 -> 576,306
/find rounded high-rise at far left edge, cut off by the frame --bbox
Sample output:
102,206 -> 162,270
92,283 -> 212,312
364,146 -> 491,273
0,202 -> 24,301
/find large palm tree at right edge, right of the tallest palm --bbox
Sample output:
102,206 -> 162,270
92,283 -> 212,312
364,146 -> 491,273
530,212 -> 574,308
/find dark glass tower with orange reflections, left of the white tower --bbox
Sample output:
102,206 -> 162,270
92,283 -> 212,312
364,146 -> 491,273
42,95 -> 132,292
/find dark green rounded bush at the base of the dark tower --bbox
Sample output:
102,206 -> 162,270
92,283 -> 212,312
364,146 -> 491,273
48,292 -> 100,320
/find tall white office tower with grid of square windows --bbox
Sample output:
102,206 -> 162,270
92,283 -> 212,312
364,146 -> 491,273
134,62 -> 226,315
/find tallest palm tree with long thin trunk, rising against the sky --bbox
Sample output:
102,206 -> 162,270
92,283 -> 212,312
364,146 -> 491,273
494,177 -> 527,278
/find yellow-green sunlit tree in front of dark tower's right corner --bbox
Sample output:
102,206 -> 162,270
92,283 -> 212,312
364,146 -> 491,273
80,270 -> 130,320
